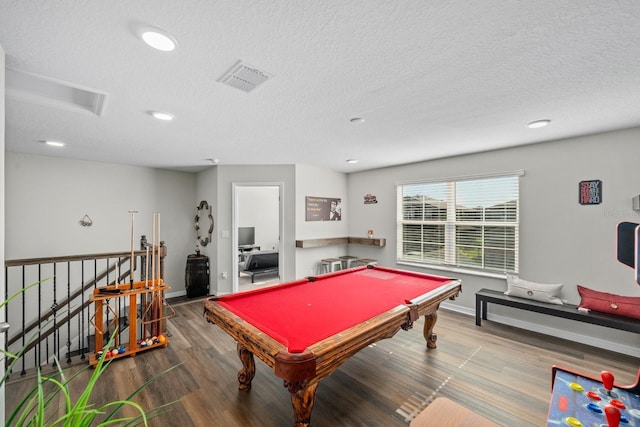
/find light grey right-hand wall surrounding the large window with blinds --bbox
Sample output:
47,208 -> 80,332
348,128 -> 640,356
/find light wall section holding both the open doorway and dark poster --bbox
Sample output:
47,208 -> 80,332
197,165 -> 352,295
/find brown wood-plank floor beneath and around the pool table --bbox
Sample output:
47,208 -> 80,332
6,300 -> 639,427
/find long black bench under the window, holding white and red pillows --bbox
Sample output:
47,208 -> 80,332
476,289 -> 640,333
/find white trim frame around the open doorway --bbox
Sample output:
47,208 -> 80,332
231,182 -> 284,293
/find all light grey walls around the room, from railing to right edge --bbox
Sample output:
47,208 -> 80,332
5,128 -> 640,356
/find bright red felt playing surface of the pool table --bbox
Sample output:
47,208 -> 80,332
218,267 -> 451,353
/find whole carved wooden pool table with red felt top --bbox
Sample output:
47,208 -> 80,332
204,266 -> 462,427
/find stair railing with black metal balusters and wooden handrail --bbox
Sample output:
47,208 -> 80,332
4,236 -> 167,375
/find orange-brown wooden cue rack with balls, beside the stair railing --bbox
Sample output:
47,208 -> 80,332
89,279 -> 172,366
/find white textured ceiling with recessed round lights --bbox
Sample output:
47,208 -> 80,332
0,0 -> 640,172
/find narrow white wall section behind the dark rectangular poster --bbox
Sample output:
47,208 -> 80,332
295,165 -> 353,279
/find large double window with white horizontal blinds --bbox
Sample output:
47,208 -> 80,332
397,172 -> 523,273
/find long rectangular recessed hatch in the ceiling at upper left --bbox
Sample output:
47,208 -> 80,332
5,68 -> 107,116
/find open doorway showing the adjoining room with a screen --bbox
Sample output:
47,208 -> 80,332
231,182 -> 284,293
